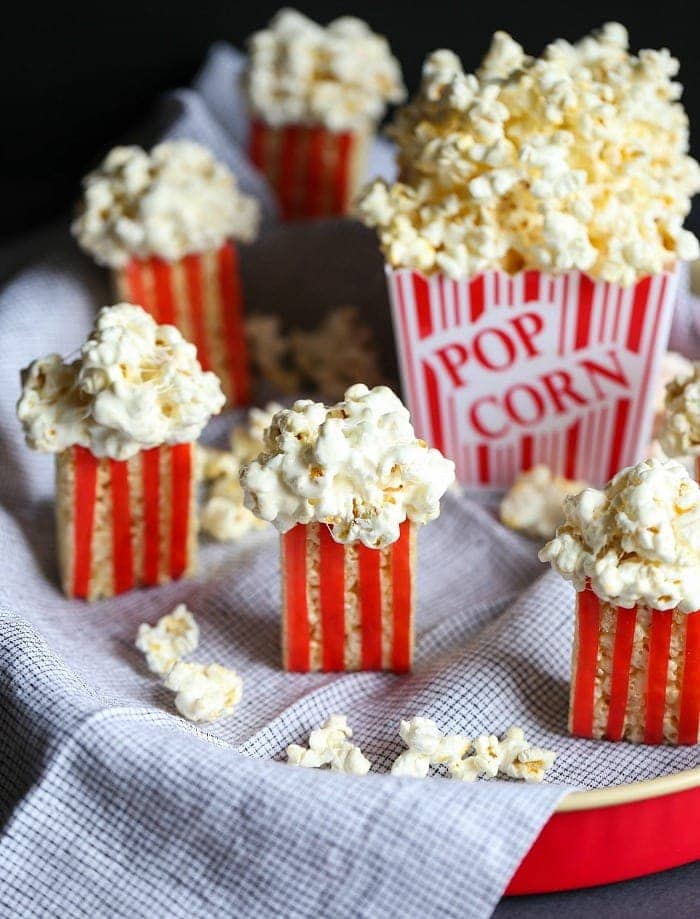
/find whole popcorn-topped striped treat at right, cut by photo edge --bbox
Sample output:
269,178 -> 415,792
540,460 -> 700,744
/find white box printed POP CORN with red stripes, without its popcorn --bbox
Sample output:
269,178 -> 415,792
386,267 -> 676,488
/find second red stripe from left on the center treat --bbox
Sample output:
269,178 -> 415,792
318,525 -> 345,671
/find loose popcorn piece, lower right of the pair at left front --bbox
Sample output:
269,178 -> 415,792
163,661 -> 243,722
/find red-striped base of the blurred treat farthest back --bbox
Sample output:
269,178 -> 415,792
250,119 -> 369,220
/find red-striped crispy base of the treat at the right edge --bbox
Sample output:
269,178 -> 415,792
569,587 -> 700,744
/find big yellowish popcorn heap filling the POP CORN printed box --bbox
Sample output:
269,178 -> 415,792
359,23 -> 700,285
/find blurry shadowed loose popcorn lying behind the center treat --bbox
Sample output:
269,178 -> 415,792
246,306 -> 383,400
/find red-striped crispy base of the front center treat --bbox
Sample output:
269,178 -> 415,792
281,521 -> 416,673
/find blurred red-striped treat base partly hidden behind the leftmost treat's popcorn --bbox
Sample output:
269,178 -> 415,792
115,242 -> 250,406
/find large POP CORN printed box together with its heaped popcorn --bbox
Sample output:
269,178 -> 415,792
359,23 -> 700,487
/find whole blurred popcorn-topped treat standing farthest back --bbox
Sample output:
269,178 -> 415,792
245,9 -> 404,219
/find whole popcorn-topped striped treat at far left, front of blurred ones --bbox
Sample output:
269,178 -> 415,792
17,303 -> 224,600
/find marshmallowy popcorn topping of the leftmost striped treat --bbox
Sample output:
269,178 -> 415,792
17,303 -> 224,460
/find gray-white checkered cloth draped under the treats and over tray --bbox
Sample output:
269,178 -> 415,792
0,46 -> 697,919
